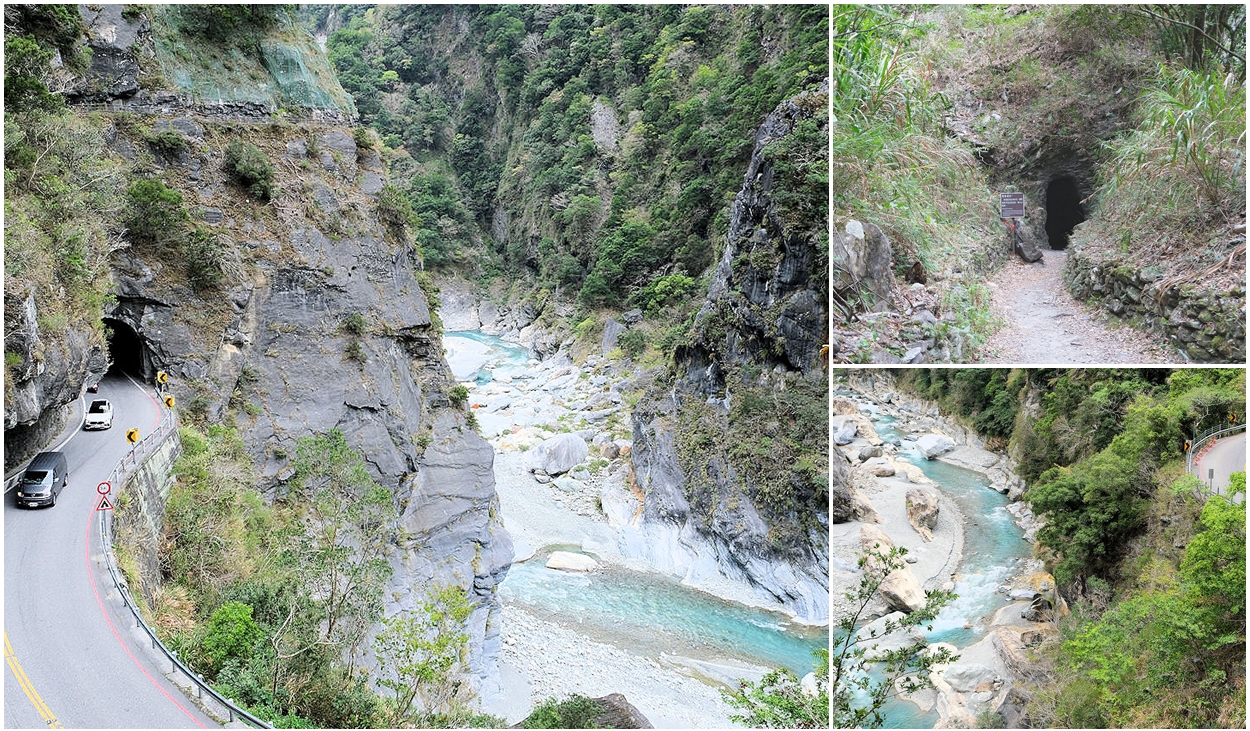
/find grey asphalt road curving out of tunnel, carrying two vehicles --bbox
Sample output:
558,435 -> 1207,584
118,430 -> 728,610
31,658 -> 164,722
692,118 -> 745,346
4,375 -> 220,729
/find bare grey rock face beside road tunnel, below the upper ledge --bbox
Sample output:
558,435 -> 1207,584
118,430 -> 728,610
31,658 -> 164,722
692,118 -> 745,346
62,120 -> 513,694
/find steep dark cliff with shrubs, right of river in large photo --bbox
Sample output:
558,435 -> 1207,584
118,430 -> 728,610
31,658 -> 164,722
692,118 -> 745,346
634,87 -> 829,622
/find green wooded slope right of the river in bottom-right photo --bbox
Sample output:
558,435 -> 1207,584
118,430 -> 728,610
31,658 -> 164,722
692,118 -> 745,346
899,369 -> 1246,729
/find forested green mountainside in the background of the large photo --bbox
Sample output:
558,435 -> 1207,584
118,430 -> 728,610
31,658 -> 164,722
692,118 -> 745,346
308,5 -> 828,314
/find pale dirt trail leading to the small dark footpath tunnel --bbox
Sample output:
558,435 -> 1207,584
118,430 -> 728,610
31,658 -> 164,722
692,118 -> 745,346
981,250 -> 1176,365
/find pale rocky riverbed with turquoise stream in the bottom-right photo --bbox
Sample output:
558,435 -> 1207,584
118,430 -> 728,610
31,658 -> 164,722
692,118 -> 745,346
833,374 -> 1065,727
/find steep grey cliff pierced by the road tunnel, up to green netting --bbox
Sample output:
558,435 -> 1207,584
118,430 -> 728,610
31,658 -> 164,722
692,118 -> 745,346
5,6 -> 513,687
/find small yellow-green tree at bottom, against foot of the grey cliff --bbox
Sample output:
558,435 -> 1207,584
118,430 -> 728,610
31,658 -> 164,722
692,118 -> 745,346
375,586 -> 473,727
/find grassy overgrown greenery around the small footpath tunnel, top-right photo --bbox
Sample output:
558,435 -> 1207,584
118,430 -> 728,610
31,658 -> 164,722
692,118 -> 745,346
831,5 -> 1245,362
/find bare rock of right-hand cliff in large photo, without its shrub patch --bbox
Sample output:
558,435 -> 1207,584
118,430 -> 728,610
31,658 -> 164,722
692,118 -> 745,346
625,82 -> 830,622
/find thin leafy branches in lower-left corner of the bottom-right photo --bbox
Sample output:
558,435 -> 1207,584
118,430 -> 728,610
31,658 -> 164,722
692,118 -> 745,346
830,547 -> 959,729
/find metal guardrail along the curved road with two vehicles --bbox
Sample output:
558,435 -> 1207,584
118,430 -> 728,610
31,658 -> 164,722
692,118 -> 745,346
93,402 -> 273,729
